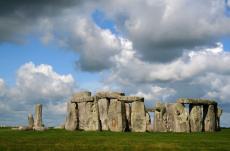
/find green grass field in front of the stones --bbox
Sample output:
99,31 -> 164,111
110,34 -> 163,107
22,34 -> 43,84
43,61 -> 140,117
0,128 -> 230,151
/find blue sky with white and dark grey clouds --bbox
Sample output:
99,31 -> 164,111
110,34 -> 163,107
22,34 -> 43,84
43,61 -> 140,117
0,0 -> 230,127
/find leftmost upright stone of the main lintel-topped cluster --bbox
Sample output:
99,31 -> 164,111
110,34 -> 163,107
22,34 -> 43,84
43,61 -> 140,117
65,102 -> 78,131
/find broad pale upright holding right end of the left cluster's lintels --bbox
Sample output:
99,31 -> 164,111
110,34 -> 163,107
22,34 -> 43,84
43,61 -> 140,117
131,101 -> 146,132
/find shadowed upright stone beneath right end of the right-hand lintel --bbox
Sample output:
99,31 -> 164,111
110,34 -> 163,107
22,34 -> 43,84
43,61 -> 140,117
204,105 -> 216,132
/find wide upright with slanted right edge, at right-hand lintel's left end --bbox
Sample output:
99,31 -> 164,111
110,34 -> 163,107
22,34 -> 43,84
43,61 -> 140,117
174,103 -> 190,132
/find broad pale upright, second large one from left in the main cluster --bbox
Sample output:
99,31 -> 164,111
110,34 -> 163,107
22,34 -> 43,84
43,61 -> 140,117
84,100 -> 100,131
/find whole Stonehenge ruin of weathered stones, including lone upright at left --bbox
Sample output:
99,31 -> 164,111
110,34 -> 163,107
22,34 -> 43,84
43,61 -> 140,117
63,91 -> 223,133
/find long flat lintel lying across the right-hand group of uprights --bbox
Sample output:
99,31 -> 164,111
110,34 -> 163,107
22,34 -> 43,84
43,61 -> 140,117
176,98 -> 217,105
